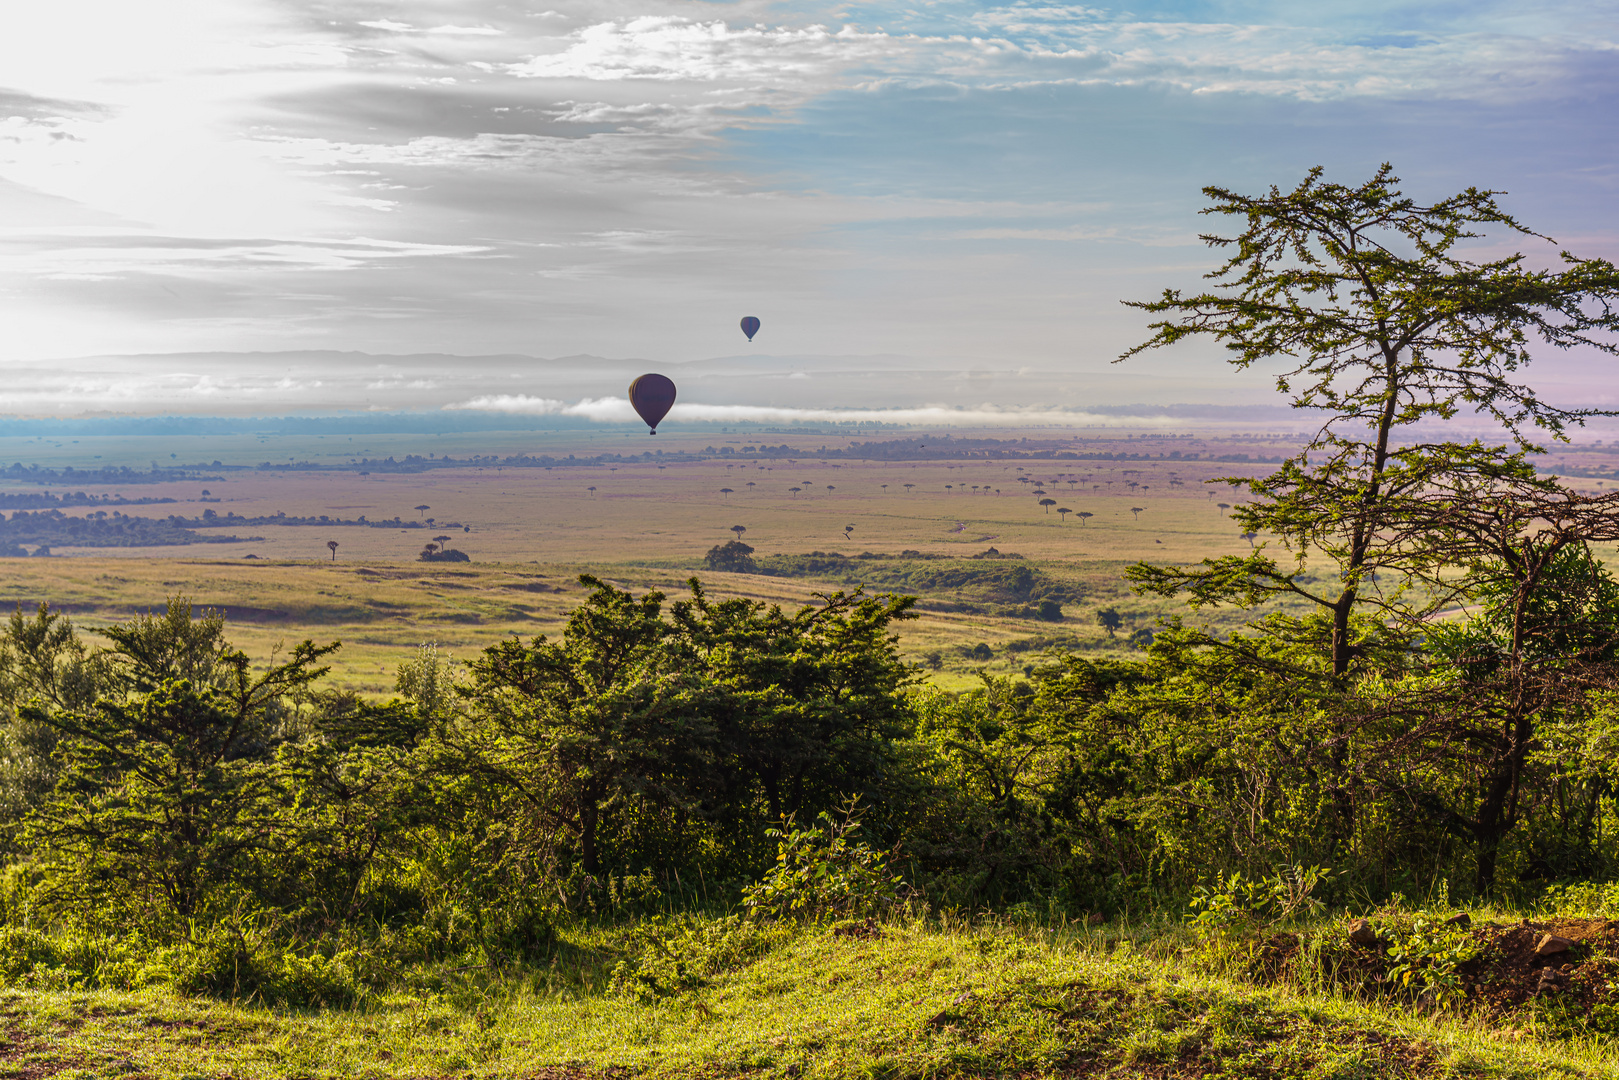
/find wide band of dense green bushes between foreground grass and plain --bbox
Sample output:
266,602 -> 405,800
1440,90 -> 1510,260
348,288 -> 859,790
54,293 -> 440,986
9,562 -> 1619,959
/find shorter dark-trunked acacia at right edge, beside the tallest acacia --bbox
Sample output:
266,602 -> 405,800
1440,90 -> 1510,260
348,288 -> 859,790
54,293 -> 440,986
1363,474 -> 1619,894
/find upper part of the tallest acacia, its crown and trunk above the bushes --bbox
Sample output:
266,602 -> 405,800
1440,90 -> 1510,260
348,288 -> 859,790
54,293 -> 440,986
1119,165 -> 1619,683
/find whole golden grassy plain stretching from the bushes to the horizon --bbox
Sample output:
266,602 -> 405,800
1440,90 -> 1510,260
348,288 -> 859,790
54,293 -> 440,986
0,432 -> 1277,693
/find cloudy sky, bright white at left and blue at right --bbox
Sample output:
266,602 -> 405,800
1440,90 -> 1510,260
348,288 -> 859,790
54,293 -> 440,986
0,0 -> 1619,413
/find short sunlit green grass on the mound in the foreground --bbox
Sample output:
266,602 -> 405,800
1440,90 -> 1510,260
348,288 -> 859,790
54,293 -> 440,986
0,920 -> 1619,1080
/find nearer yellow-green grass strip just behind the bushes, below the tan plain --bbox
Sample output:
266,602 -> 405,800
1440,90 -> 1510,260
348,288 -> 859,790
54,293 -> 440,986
0,552 -> 1275,695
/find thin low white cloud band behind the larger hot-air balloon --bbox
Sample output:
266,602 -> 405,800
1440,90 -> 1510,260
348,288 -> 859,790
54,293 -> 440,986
445,393 -> 1187,427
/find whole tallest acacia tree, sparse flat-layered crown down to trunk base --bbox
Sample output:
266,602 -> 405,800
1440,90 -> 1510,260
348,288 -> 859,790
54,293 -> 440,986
1120,165 -> 1619,887
